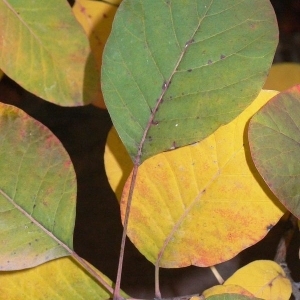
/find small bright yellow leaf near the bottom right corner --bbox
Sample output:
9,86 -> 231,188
224,260 -> 292,300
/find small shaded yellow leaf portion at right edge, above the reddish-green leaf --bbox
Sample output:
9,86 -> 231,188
264,63 -> 300,91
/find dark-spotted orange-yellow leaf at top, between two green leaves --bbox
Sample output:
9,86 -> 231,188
73,0 -> 121,108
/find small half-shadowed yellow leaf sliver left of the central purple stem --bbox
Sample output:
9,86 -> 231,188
104,127 -> 133,201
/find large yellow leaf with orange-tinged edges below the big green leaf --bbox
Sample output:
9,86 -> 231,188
121,91 -> 284,268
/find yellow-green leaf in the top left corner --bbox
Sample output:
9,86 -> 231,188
0,0 -> 99,106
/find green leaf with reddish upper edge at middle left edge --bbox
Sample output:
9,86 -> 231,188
0,103 -> 76,270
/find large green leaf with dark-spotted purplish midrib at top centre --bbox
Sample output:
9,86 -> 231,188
102,0 -> 278,161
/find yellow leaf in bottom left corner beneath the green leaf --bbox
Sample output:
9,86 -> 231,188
0,257 -> 124,300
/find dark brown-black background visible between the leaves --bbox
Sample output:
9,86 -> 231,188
0,0 -> 300,298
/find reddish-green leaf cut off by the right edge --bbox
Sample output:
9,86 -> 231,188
248,85 -> 300,218
